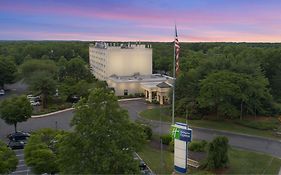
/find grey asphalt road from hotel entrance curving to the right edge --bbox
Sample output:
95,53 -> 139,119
120,100 -> 281,158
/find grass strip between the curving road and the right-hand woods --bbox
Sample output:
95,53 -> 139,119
140,108 -> 280,139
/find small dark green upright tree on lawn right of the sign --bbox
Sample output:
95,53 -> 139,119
206,136 -> 229,170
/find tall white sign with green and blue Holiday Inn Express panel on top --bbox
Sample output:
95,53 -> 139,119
172,122 -> 192,173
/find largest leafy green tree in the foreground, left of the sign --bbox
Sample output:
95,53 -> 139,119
59,88 -> 145,174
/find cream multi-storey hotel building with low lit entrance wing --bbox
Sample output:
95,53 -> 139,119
89,42 -> 173,104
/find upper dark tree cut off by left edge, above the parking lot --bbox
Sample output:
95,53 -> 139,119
0,57 -> 17,89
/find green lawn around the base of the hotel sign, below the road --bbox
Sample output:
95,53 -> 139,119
139,144 -> 281,174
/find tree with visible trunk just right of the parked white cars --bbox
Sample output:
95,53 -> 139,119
28,72 -> 56,108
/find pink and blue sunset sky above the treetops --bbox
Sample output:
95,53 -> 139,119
0,0 -> 281,42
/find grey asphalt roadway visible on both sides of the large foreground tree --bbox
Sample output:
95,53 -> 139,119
0,100 -> 281,158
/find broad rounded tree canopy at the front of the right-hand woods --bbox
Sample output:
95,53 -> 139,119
198,71 -> 271,117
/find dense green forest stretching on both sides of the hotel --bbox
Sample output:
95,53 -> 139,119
0,41 -> 281,119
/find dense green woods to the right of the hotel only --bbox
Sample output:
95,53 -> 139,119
153,43 -> 281,119
